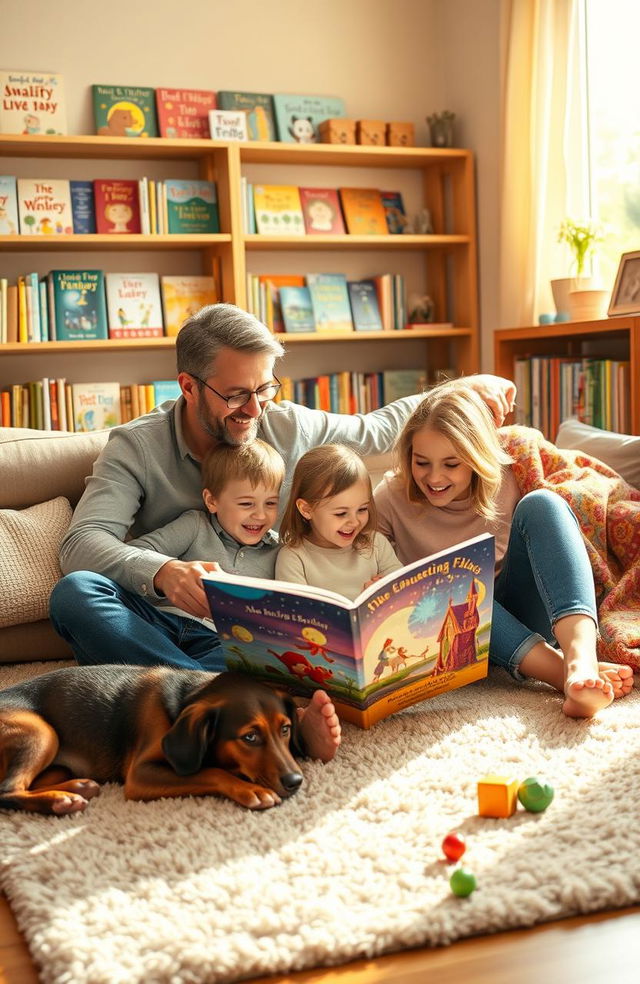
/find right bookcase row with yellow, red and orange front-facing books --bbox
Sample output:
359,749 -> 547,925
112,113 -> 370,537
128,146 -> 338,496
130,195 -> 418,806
241,177 -> 408,236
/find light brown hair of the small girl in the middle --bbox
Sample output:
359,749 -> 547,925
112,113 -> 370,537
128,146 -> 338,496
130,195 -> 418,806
280,444 -> 377,551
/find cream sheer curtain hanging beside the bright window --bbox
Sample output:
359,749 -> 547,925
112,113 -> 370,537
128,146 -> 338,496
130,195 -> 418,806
499,0 -> 589,327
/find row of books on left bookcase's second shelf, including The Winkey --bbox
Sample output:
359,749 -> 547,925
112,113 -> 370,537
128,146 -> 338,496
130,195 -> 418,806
0,175 -> 220,236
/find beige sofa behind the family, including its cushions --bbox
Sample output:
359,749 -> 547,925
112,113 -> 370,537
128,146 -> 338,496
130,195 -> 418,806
0,421 -> 640,663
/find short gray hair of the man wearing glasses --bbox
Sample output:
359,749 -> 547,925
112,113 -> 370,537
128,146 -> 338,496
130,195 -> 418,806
176,304 -> 284,379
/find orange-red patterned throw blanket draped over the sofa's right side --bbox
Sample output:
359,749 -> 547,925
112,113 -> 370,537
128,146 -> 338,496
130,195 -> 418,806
500,427 -> 640,672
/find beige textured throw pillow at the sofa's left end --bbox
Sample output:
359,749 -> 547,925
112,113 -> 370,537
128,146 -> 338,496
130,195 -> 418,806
0,496 -> 72,628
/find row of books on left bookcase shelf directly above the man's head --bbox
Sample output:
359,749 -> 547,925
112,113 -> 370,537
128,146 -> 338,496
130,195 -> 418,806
0,270 -> 220,344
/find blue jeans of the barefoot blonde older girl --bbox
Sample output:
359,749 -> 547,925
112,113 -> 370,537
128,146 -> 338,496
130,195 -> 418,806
489,489 -> 598,680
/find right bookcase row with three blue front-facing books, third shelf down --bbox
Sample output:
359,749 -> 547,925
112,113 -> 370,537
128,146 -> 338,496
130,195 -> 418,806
247,273 -> 407,332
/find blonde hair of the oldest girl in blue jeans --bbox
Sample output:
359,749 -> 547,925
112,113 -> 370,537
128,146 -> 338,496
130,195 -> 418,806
394,379 -> 512,522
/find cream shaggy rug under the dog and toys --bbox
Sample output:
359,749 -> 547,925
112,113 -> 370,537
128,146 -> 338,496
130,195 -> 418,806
0,664 -> 640,984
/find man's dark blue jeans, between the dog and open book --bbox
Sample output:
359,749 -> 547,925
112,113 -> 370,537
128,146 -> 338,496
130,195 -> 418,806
50,571 -> 225,673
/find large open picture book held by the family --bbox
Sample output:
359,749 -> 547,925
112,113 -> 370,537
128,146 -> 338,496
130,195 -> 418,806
202,534 -> 495,728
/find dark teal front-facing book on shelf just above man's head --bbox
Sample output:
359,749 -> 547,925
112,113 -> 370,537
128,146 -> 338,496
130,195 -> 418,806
48,270 -> 108,342
